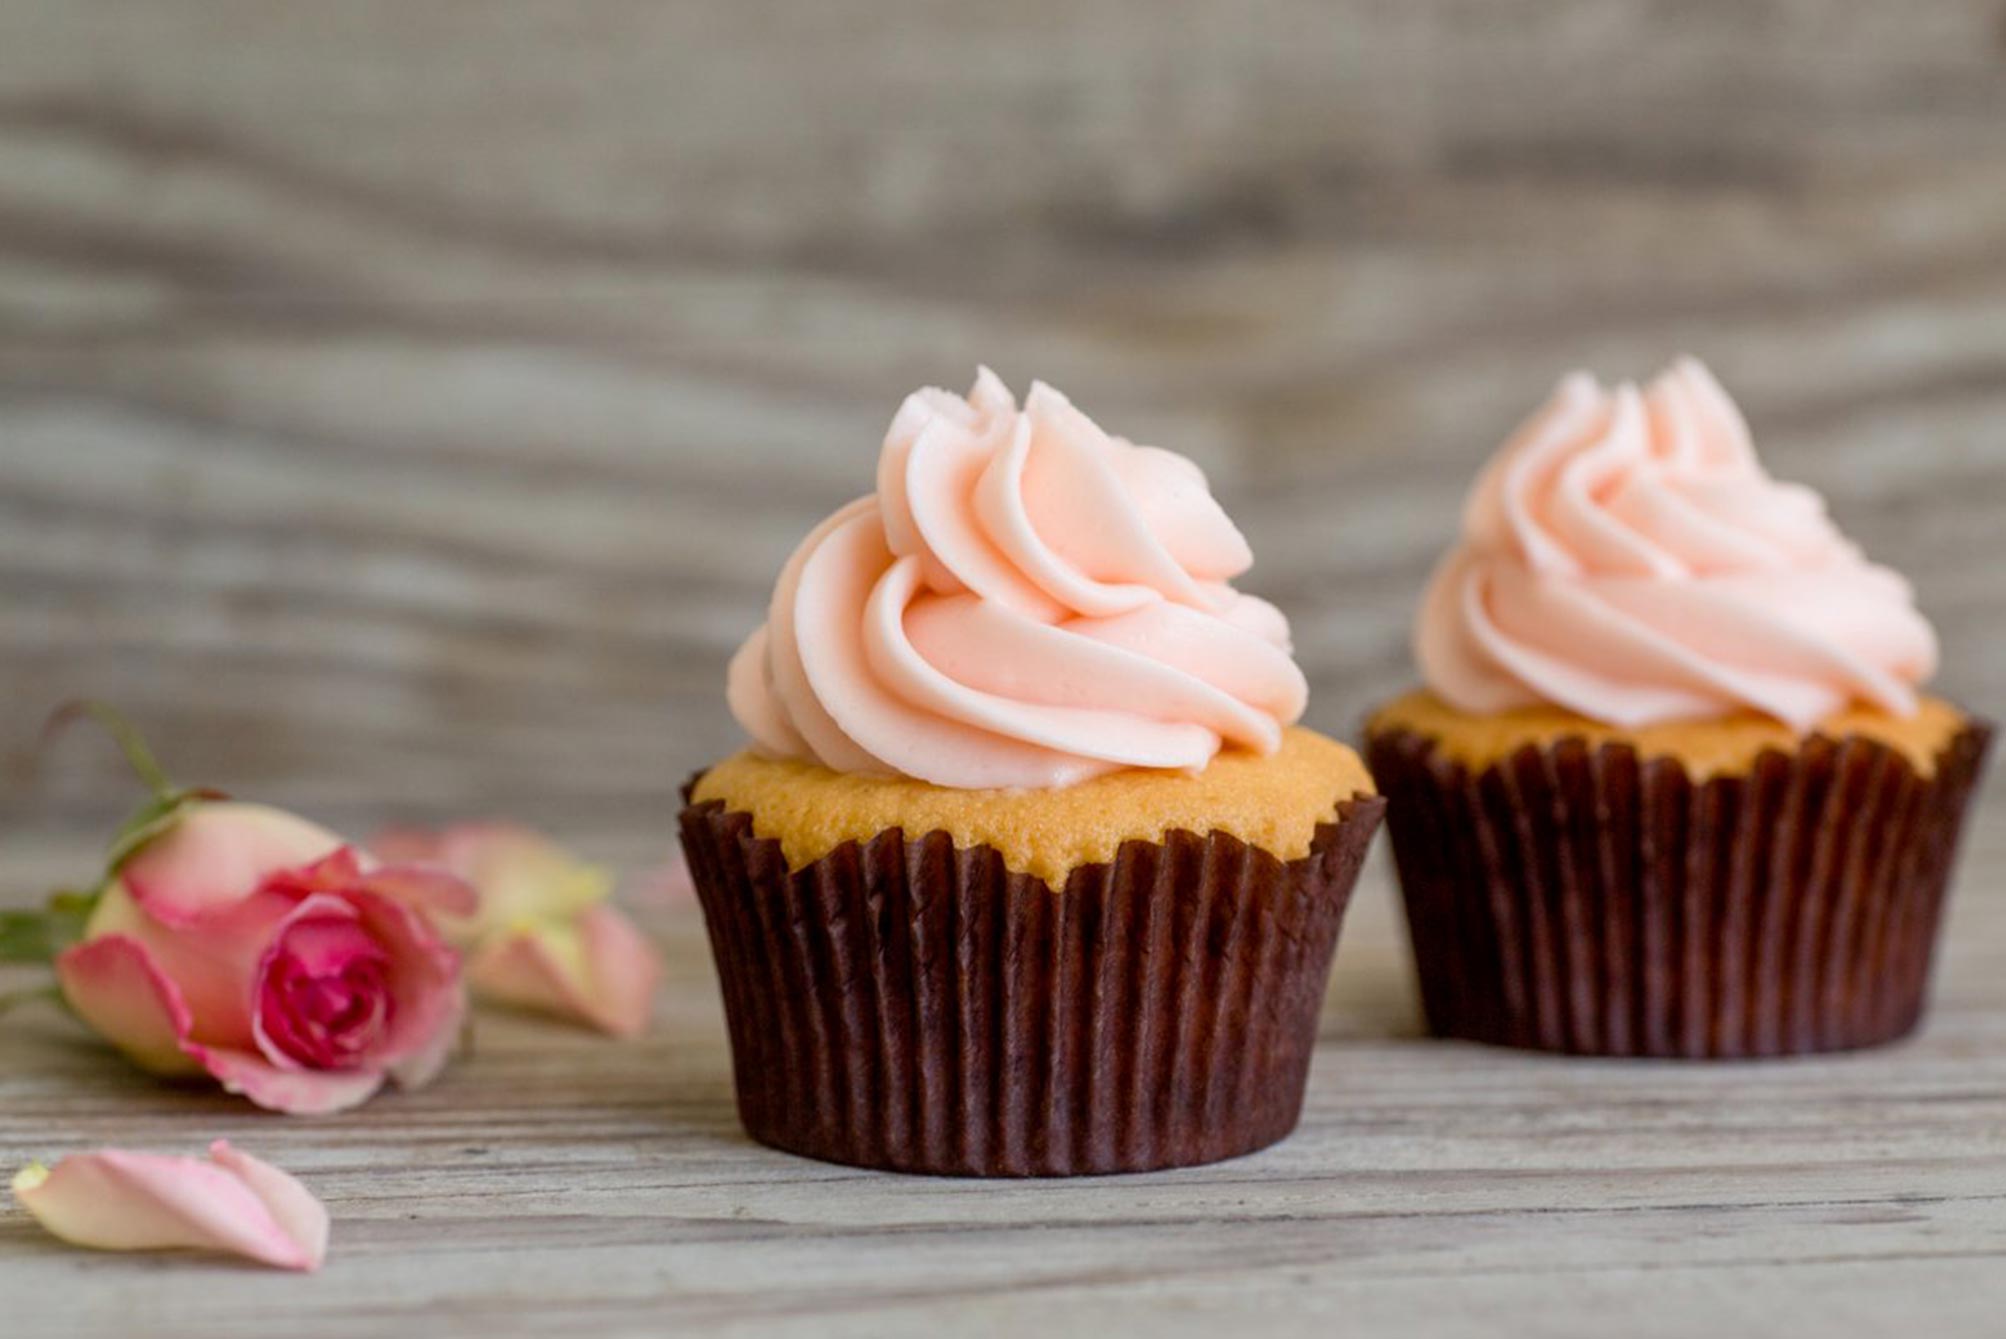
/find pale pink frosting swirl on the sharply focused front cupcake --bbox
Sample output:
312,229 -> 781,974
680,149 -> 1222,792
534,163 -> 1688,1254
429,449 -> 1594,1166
730,367 -> 1308,789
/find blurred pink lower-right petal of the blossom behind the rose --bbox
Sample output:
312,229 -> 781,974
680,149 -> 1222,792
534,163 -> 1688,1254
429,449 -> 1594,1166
467,905 -> 662,1038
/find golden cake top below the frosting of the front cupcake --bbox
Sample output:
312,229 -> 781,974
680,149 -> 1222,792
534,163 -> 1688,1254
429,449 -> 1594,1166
692,727 -> 1374,887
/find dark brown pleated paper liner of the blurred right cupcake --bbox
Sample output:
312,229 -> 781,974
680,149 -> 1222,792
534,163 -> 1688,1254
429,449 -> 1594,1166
1366,723 -> 1992,1058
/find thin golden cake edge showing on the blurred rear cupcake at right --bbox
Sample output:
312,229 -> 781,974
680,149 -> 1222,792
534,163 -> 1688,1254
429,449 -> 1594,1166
1366,689 -> 1966,779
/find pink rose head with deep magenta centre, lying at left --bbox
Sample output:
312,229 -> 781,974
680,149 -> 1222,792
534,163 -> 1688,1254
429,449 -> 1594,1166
56,803 -> 475,1114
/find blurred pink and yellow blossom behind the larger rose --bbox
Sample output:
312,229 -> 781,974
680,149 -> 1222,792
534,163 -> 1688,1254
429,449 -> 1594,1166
377,823 -> 662,1036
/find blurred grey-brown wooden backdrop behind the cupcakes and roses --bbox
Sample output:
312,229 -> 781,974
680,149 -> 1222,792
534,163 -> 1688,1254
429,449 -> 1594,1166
0,0 -> 2006,871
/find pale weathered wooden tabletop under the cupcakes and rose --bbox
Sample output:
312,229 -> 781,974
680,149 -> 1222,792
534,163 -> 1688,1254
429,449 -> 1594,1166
0,803 -> 2006,1339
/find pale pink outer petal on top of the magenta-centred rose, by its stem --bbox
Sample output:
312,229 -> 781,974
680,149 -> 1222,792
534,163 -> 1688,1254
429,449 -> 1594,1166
120,801 -> 341,925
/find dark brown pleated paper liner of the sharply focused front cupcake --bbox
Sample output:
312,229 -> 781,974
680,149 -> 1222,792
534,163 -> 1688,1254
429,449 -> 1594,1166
682,797 -> 1384,1176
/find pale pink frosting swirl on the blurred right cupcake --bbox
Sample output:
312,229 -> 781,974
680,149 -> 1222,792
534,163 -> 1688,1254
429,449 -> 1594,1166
1414,359 -> 1936,731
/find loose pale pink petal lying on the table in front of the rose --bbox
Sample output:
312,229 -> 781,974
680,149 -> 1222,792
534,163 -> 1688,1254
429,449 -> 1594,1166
14,1140 -> 327,1271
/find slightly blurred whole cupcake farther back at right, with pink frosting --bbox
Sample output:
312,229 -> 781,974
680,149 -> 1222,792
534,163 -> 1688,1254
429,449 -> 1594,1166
1366,359 -> 1990,1058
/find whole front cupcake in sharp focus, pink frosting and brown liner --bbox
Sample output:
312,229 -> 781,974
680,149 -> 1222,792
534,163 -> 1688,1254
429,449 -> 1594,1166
682,371 -> 1382,1176
